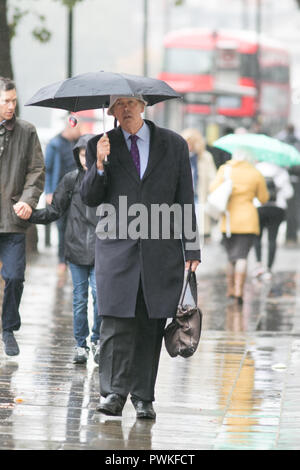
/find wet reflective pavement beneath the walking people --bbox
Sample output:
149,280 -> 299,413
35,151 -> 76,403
0,229 -> 300,451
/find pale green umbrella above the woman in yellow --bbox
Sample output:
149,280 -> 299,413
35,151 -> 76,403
213,134 -> 300,167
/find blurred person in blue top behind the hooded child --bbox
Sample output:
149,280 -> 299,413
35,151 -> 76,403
45,122 -> 81,275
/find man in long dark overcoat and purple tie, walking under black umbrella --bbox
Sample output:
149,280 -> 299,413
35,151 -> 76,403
81,96 -> 200,419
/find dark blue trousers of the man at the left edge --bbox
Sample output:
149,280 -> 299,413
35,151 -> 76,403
0,233 -> 26,331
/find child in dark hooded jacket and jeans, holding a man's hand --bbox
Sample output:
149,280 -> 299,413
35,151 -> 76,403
18,134 -> 101,364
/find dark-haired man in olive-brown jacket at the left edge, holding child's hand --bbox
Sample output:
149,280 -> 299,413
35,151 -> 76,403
0,77 -> 45,356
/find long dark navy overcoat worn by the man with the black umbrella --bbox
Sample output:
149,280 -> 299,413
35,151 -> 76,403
81,120 -> 200,318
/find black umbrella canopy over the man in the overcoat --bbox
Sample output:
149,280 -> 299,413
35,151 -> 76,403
25,71 -> 181,112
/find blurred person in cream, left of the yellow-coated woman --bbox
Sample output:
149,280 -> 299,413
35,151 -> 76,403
181,128 -> 217,240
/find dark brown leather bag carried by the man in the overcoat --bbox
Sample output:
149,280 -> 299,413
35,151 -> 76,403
164,270 -> 202,357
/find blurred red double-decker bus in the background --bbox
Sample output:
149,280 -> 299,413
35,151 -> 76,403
159,29 -> 290,133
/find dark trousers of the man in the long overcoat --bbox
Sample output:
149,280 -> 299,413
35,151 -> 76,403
99,280 -> 166,401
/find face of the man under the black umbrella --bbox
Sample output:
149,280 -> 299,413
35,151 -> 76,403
113,98 -> 145,129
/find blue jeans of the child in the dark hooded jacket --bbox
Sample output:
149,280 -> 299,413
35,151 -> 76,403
69,263 -> 101,348
